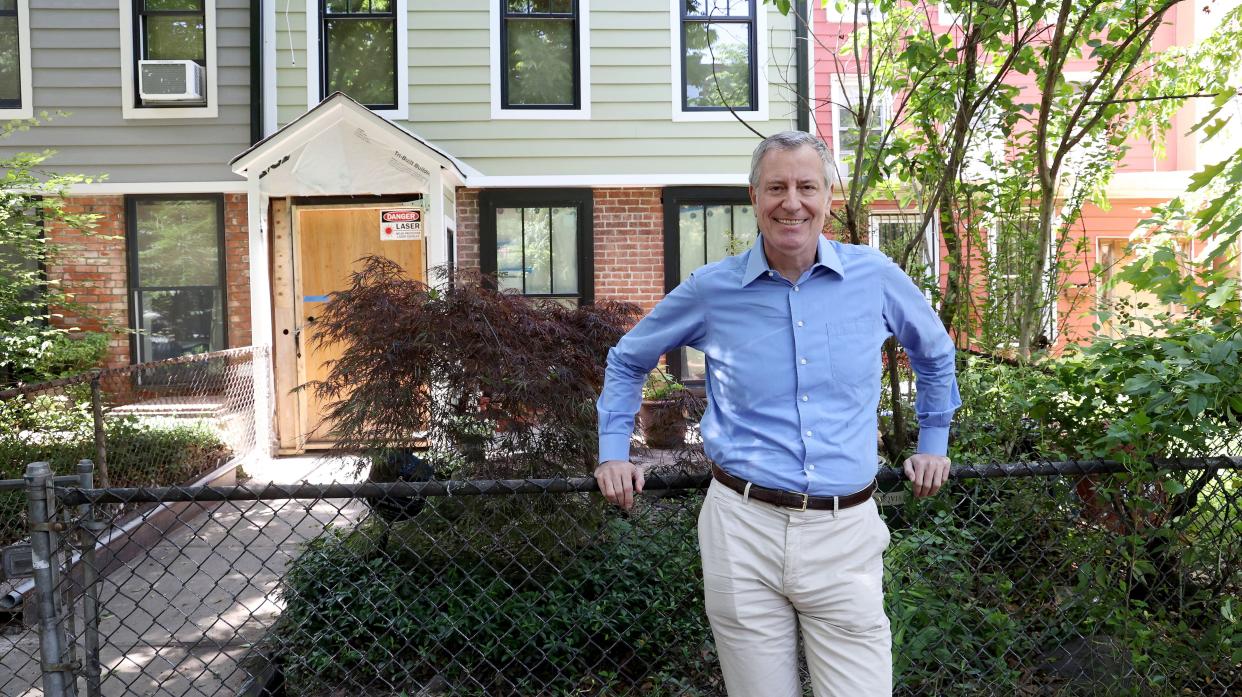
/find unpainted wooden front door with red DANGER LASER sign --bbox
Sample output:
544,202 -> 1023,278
273,204 -> 426,451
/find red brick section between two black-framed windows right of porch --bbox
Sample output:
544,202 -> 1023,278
595,188 -> 664,311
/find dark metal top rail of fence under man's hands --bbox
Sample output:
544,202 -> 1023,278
56,455 -> 1242,506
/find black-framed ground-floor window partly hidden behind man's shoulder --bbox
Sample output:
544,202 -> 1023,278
663,186 -> 759,385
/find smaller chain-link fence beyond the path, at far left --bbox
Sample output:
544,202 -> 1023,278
0,347 -> 266,549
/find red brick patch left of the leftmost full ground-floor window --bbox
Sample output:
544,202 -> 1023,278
45,196 -> 129,367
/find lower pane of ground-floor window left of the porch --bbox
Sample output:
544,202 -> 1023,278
137,288 -> 224,360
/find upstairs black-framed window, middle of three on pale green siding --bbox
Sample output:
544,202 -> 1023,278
498,0 -> 582,109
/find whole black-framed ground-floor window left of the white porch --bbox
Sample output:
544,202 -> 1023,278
125,194 -> 229,363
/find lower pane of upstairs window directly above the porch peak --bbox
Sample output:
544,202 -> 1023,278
324,20 -> 396,104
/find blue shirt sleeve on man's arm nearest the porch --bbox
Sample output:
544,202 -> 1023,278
596,275 -> 704,462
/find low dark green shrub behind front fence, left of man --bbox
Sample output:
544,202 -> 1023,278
273,496 -> 718,696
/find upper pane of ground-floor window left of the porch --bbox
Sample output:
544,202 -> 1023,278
134,200 -> 220,287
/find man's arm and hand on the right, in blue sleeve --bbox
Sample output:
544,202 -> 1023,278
882,262 -> 961,496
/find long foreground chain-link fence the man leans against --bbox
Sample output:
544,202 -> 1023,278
0,457 -> 1242,697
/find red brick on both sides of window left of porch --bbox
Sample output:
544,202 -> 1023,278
46,194 -> 251,368
